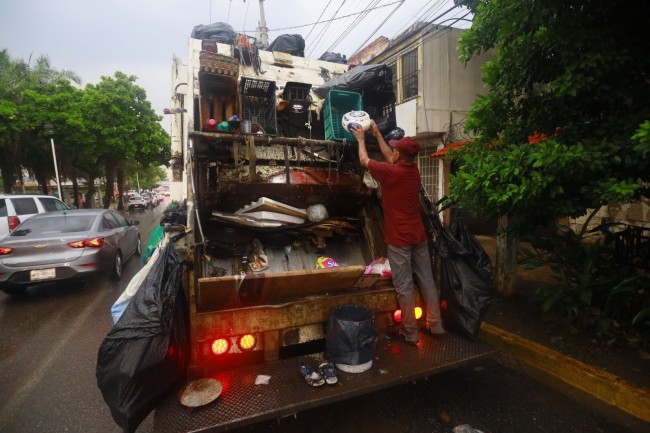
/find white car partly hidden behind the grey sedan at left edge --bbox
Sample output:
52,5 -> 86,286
0,194 -> 70,239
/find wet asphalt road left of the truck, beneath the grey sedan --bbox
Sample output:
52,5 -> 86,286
0,198 -> 169,432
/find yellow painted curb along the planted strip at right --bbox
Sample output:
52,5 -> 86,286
480,322 -> 650,422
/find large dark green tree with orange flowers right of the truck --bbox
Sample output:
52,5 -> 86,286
450,0 -> 650,293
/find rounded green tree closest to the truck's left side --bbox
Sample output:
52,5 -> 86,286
83,71 -> 171,209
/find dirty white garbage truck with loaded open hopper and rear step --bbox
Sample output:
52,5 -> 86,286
147,24 -> 494,432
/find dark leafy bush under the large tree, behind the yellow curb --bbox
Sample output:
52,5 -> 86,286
520,209 -> 650,345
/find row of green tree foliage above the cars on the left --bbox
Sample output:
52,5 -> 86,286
0,49 -> 171,206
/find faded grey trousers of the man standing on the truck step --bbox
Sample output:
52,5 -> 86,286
388,242 -> 445,341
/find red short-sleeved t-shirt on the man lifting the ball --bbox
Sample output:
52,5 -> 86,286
368,159 -> 427,248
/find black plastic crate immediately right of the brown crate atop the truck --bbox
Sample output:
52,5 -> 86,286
239,77 -> 278,135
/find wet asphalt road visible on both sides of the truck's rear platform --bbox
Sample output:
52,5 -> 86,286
0,198 -> 650,433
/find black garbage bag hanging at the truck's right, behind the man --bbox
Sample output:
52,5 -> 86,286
436,210 -> 495,340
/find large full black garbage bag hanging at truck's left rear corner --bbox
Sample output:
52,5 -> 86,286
95,244 -> 189,432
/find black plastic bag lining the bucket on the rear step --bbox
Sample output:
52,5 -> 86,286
325,304 -> 379,365
